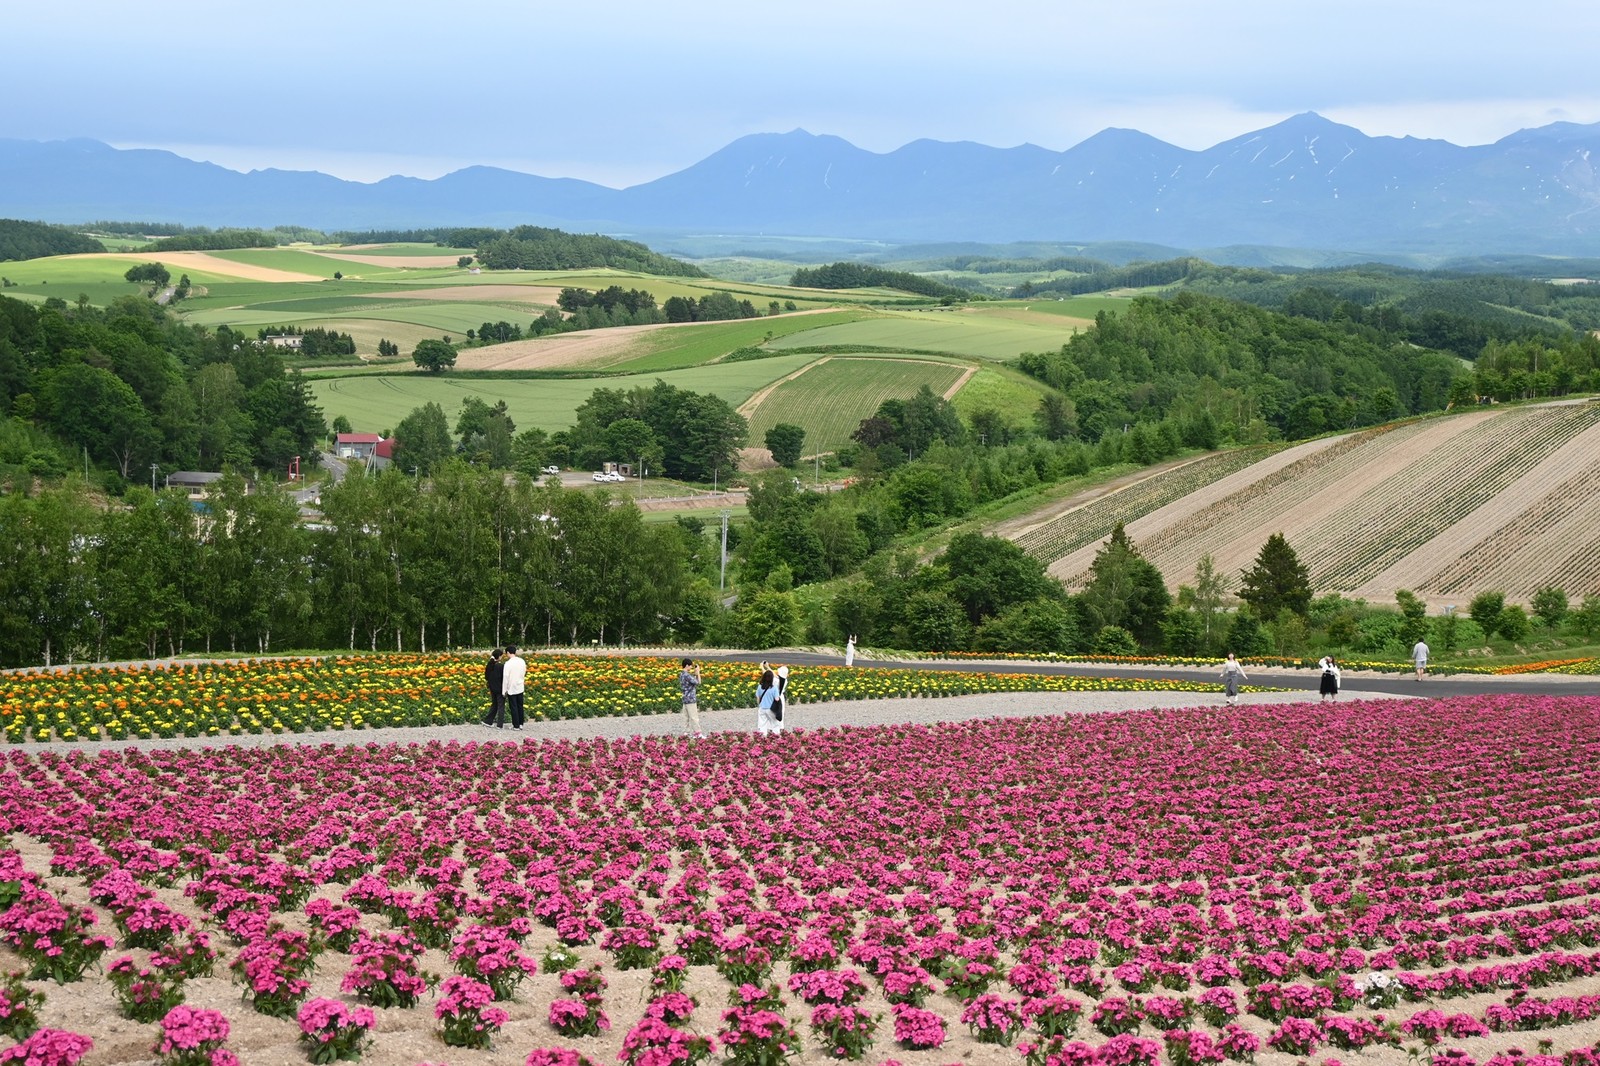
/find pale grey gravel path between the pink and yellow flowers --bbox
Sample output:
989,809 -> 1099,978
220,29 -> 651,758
3,691 -> 1397,754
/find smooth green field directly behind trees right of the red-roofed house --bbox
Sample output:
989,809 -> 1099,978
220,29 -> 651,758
310,350 -> 816,432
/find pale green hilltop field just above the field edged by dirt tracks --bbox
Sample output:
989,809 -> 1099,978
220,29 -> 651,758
758,311 -> 1072,360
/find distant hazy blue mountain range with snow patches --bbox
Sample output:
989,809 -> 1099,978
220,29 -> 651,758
0,112 -> 1600,256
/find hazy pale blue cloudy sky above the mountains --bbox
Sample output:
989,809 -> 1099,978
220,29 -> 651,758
0,0 -> 1600,185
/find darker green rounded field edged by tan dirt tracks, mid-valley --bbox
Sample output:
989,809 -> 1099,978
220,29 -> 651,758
734,355 -> 966,455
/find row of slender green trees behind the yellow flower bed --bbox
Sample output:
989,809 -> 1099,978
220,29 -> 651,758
0,463 -> 709,666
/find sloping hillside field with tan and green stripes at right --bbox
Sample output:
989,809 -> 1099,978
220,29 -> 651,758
1013,402 -> 1600,610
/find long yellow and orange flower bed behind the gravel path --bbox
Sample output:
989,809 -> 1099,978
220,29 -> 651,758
0,655 -> 1214,743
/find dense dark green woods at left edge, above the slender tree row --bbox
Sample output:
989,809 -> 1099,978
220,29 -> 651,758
0,296 -> 328,491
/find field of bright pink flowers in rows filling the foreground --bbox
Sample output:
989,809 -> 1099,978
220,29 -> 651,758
0,696 -> 1600,1066
